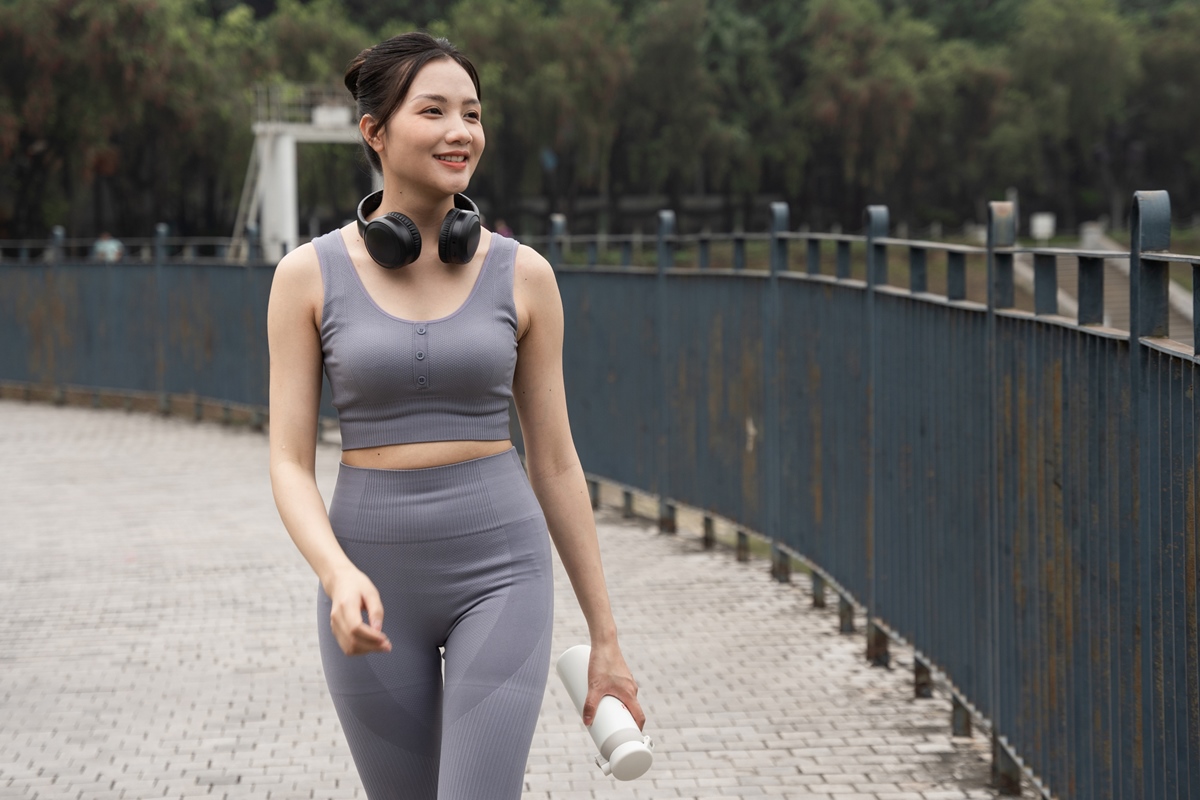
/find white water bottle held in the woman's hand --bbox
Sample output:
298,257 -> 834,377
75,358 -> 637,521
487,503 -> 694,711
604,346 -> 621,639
554,644 -> 654,781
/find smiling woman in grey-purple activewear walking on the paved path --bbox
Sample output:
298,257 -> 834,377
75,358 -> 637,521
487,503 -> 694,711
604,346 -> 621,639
268,34 -> 644,800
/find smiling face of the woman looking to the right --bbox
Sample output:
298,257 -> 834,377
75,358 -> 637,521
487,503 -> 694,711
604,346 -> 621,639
372,59 -> 484,201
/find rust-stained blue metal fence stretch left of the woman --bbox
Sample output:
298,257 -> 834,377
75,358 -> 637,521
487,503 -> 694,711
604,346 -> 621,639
0,261 -> 324,416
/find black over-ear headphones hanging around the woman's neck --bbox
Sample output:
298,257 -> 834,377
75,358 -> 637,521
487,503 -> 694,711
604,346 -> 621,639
359,190 -> 479,270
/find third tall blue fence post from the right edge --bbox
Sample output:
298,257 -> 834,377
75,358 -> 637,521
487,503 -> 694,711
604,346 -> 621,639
868,205 -> 890,666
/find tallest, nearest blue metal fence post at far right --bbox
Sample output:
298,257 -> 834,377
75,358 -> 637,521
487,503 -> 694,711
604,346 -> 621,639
1120,191 -> 1171,798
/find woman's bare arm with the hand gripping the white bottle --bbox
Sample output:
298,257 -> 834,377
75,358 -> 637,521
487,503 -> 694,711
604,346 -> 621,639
512,247 -> 646,727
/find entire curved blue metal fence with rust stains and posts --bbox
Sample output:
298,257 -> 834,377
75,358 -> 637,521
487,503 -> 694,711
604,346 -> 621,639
0,192 -> 1200,798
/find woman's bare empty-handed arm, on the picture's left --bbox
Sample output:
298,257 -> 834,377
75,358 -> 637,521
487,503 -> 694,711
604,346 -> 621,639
266,245 -> 391,655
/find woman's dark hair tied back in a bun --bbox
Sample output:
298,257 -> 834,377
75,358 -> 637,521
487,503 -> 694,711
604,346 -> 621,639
346,31 -> 484,172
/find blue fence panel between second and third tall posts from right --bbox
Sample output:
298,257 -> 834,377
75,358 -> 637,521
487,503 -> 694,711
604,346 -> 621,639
875,294 -> 992,716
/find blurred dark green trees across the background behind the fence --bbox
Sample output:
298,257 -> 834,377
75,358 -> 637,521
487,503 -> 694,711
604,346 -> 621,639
0,0 -> 1200,239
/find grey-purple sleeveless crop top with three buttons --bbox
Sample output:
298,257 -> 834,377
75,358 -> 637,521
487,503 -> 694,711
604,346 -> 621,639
312,230 -> 517,450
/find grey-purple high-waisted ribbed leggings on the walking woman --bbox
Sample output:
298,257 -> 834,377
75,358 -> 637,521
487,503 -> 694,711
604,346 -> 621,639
317,450 -> 553,800
